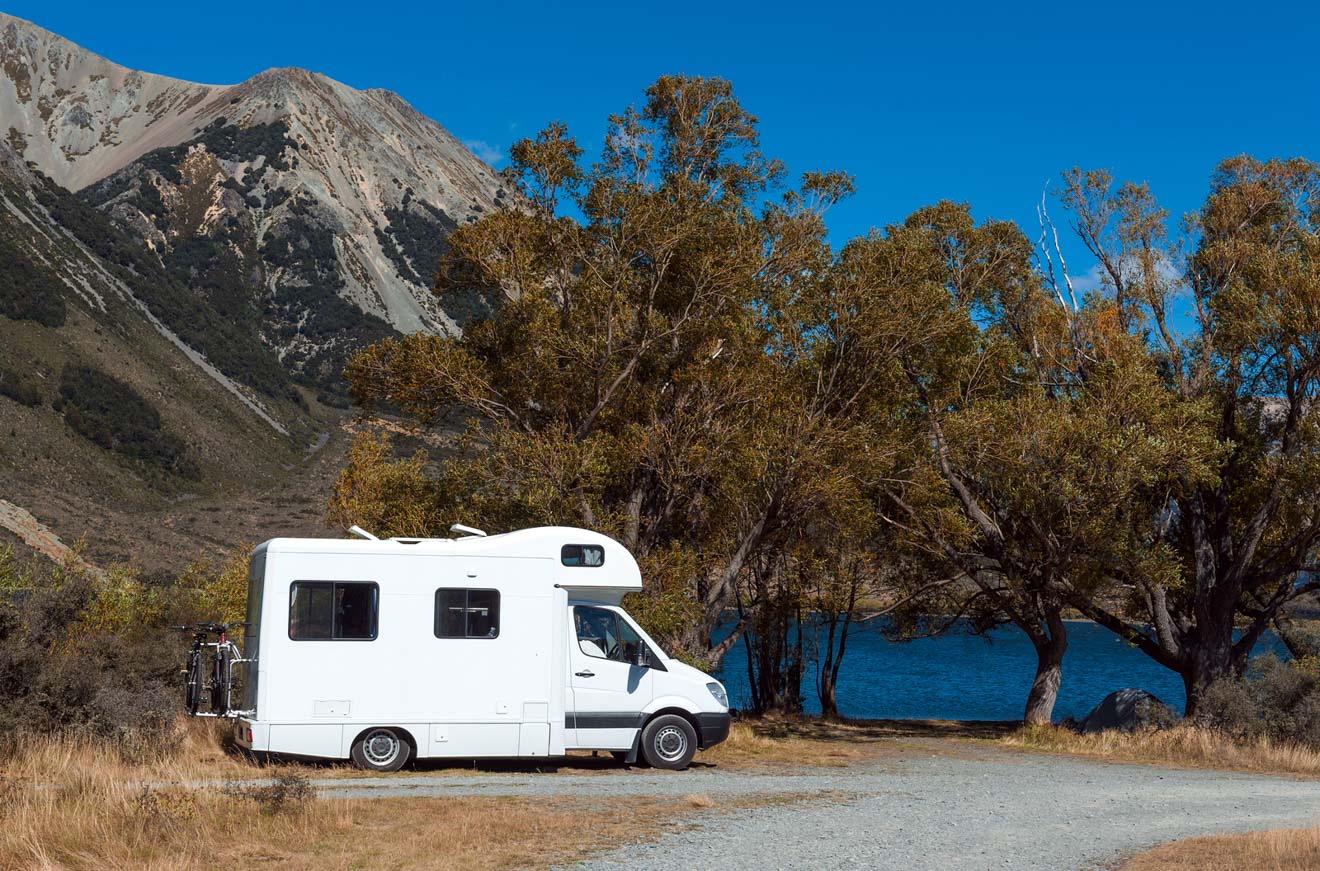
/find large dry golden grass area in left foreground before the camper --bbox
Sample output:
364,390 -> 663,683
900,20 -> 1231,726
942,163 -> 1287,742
0,734 -> 733,868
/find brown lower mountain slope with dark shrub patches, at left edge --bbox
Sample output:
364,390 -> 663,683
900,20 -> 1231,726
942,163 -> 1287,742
0,131 -> 347,571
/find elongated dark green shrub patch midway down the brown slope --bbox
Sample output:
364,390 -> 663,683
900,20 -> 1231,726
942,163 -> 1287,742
55,366 -> 199,479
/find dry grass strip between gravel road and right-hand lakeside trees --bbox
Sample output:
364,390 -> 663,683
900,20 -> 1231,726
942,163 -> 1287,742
999,726 -> 1320,776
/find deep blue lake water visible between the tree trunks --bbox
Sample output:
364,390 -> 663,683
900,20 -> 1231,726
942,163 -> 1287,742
715,622 -> 1287,721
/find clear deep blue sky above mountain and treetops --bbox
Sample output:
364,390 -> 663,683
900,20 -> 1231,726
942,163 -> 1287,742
0,0 -> 1320,289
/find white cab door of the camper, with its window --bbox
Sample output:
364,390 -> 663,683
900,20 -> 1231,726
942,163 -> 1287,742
566,604 -> 653,750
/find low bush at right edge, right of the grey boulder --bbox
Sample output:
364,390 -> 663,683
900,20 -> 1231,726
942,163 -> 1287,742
1197,656 -> 1320,748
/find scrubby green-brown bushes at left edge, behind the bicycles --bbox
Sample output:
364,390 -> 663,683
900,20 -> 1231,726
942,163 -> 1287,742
0,546 -> 243,749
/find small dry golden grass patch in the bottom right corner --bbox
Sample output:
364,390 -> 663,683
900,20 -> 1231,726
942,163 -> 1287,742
1123,827 -> 1320,871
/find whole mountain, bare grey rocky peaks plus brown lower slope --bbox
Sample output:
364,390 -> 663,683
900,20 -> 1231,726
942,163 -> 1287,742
0,13 -> 506,570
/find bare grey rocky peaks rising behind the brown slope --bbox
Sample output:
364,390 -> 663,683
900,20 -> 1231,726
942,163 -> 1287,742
0,15 -> 504,395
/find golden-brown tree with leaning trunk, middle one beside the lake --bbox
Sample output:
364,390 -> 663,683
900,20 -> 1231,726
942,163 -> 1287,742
838,203 -> 1209,723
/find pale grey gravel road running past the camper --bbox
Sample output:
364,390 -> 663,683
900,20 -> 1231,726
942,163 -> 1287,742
303,740 -> 1320,871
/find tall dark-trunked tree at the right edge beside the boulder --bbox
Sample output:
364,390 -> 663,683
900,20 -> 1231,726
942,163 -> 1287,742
1063,157 -> 1320,714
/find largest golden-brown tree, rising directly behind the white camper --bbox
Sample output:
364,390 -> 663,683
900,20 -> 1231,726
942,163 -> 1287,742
334,77 -> 849,659
